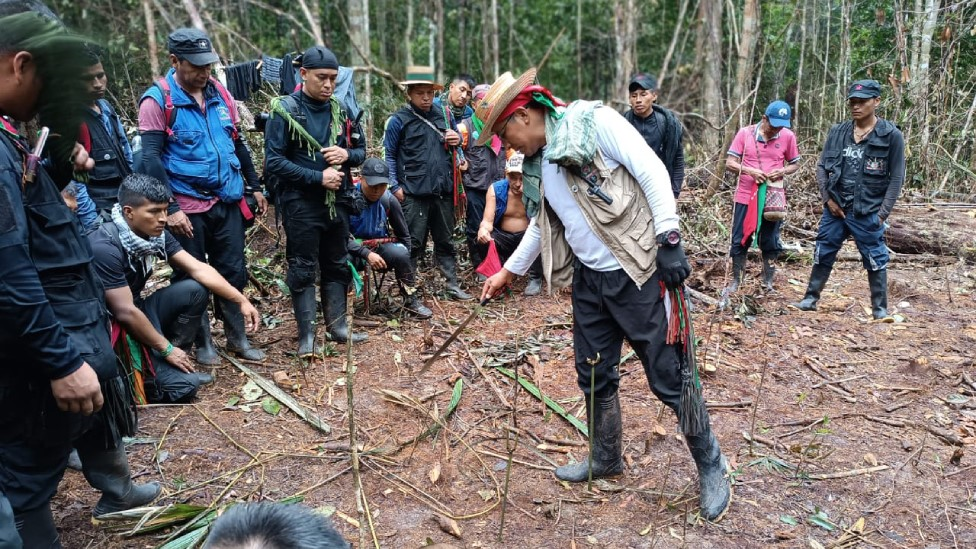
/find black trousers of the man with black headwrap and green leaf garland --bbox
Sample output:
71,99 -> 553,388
279,191 -> 352,291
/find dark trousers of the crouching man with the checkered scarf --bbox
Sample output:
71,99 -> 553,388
140,279 -> 210,403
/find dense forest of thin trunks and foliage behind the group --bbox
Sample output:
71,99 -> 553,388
53,0 -> 976,197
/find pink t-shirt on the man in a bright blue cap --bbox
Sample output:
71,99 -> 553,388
728,124 -> 800,204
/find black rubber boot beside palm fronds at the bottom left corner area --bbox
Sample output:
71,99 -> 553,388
78,442 -> 163,517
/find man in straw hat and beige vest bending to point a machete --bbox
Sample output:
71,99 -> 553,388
475,69 -> 731,521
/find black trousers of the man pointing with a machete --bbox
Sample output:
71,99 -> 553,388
573,262 -> 681,413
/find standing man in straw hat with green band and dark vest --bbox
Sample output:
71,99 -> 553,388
383,67 -> 471,301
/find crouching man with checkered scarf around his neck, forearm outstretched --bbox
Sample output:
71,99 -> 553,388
88,174 -> 261,403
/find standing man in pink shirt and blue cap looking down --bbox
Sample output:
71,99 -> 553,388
725,101 -> 800,294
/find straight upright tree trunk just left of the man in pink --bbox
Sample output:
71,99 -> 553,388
698,0 -> 725,197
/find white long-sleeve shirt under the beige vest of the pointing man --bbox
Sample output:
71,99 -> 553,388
505,107 -> 678,275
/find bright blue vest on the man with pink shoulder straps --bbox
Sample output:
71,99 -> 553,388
139,69 -> 244,202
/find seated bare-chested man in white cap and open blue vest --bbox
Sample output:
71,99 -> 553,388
478,152 -> 542,296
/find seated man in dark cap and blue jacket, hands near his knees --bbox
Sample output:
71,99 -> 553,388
348,158 -> 433,318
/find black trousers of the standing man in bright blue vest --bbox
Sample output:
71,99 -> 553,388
173,202 -> 247,290
